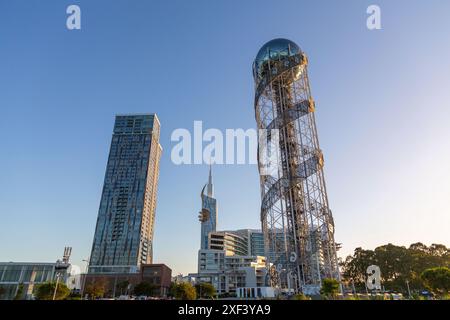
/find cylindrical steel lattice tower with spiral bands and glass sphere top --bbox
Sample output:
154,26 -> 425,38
253,39 -> 340,294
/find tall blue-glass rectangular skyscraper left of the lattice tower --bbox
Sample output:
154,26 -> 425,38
89,114 -> 162,273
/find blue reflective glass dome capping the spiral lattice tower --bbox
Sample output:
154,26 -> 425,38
253,38 -> 302,80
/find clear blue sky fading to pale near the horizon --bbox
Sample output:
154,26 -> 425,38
0,0 -> 450,273
